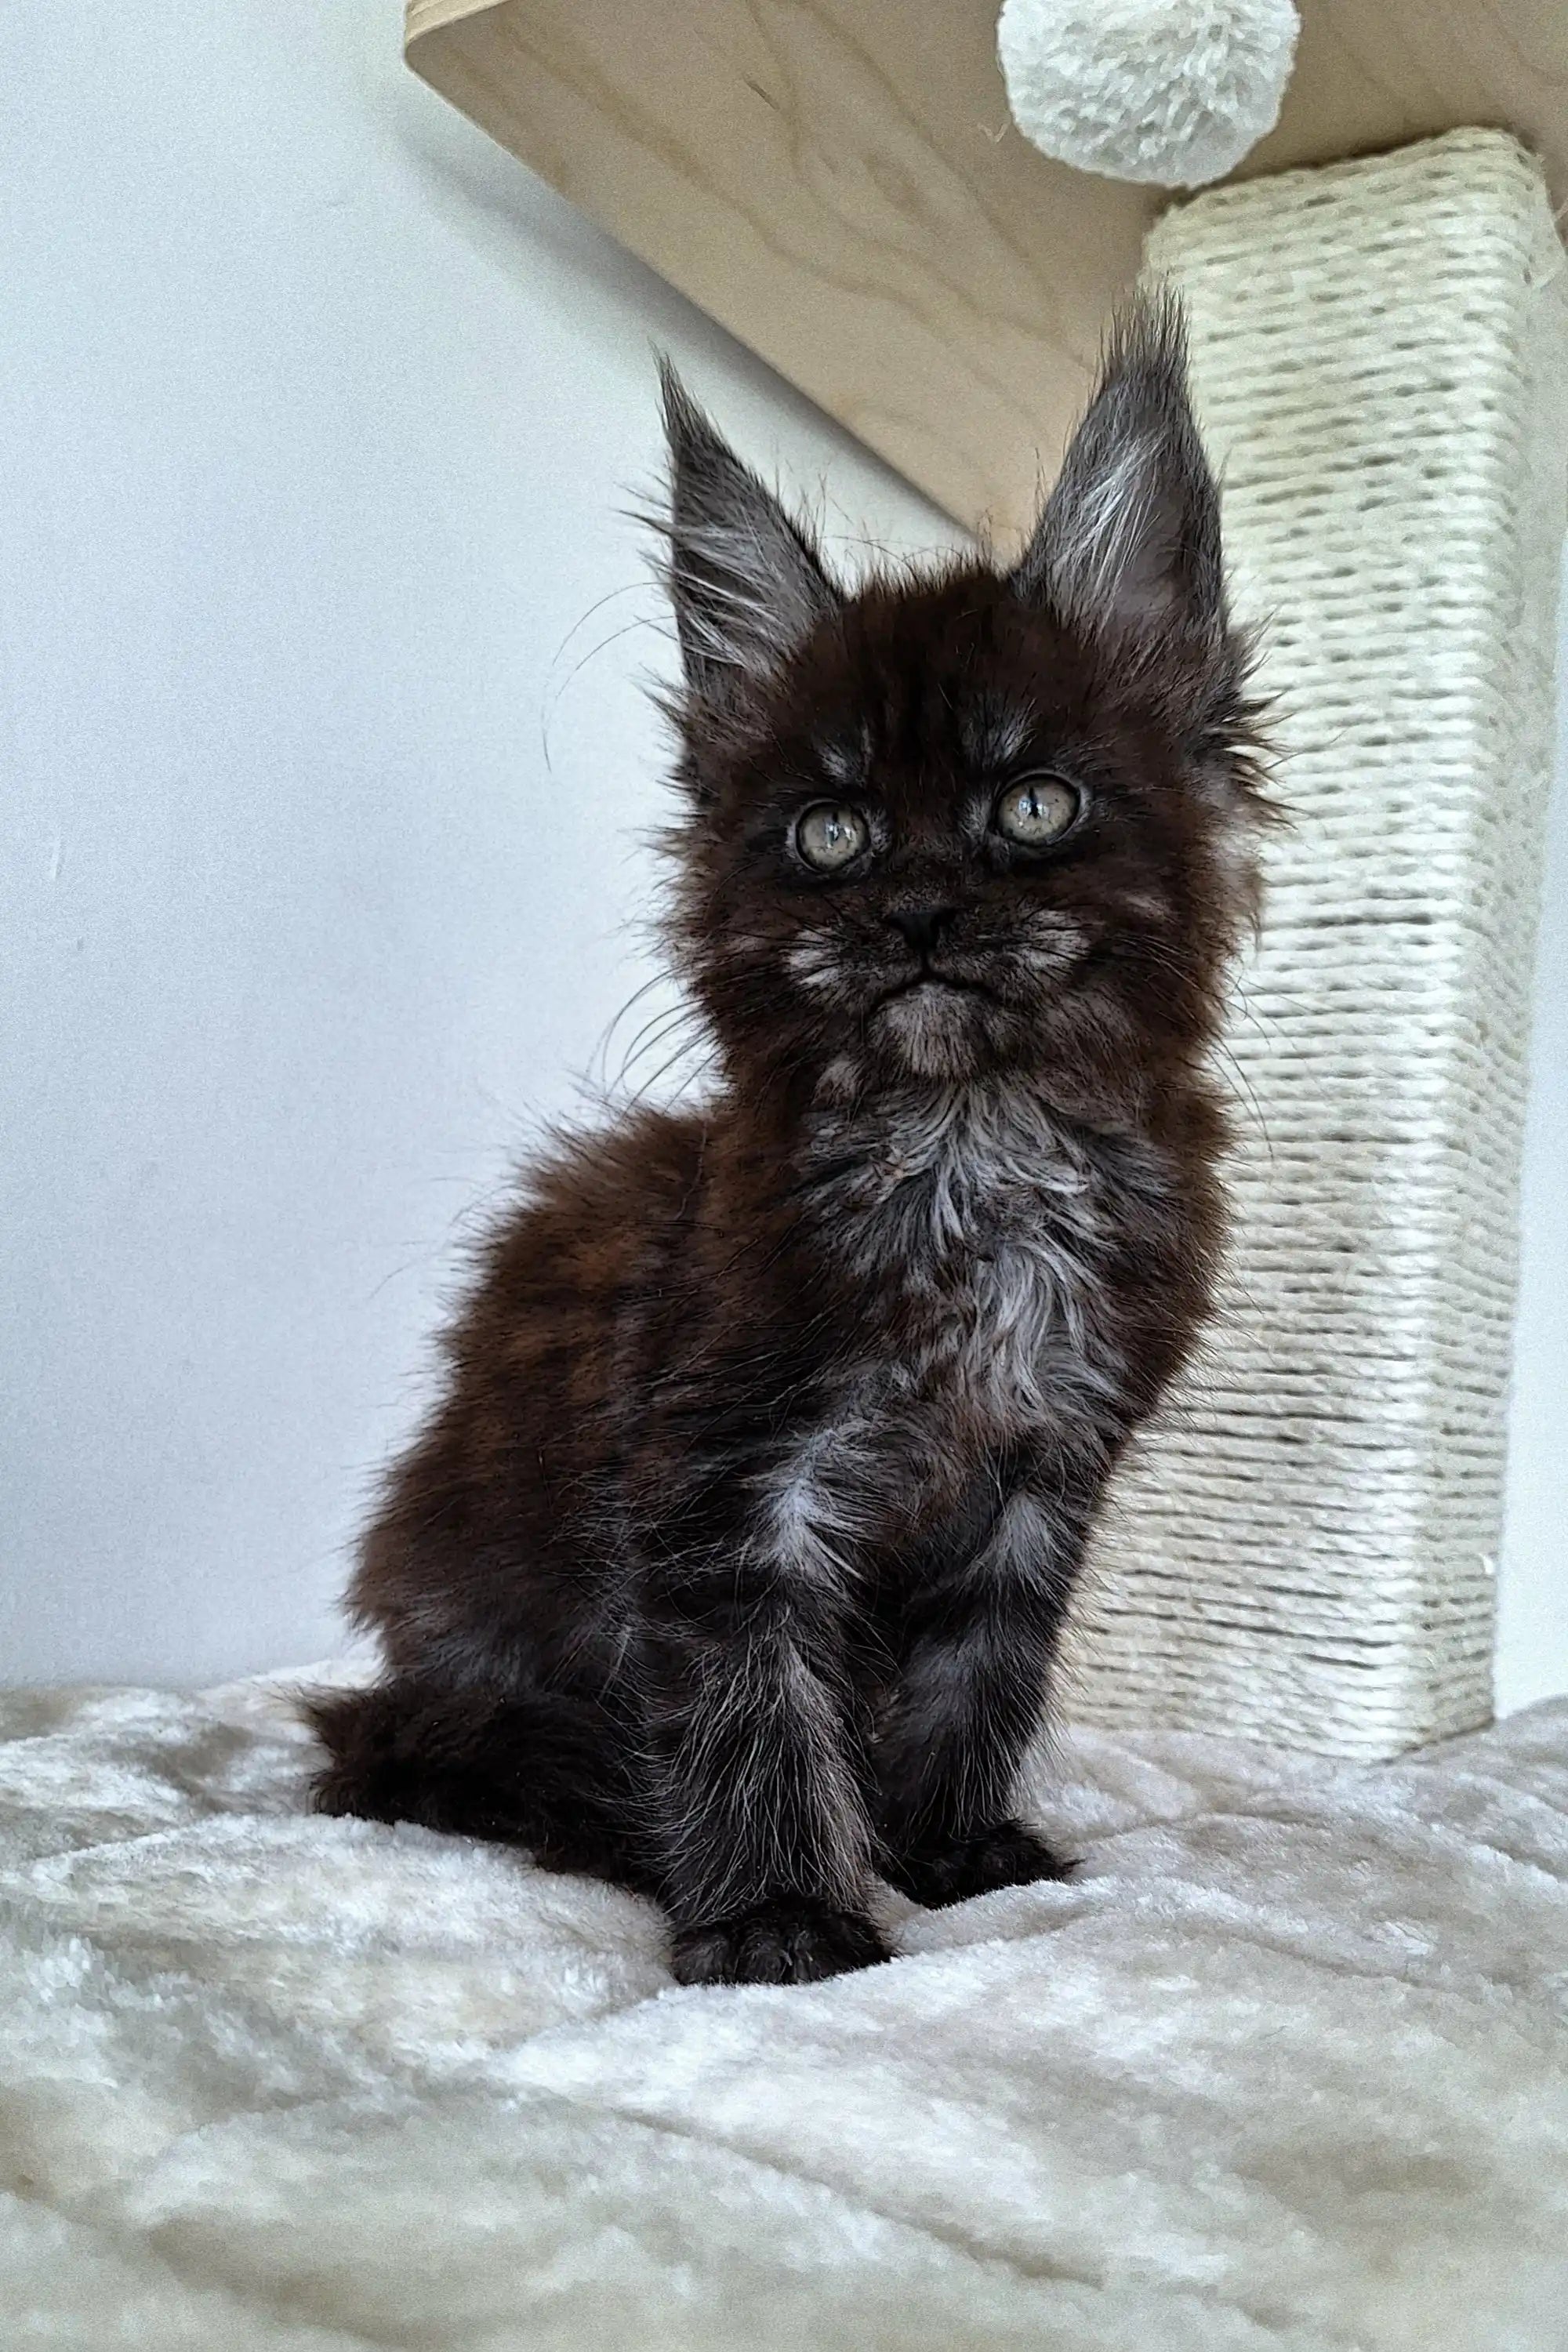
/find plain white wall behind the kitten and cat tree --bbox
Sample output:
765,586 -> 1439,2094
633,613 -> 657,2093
0,0 -> 1568,1703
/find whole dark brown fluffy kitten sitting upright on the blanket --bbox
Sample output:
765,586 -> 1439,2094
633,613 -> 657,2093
313,301 -> 1262,1983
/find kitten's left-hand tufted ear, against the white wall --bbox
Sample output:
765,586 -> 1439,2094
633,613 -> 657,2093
661,360 -> 839,710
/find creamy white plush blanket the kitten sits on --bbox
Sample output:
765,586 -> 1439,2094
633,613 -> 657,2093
0,1684 -> 1568,2352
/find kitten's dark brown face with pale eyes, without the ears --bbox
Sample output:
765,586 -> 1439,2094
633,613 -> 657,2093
684,569 -> 1241,1082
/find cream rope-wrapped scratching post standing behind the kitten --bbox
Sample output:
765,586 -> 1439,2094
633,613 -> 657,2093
1062,132 -> 1568,1759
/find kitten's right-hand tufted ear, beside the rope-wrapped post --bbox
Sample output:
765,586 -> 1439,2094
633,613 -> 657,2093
1013,292 -> 1227,656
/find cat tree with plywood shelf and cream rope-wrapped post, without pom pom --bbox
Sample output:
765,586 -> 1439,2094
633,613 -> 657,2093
409,0 -> 1568,1759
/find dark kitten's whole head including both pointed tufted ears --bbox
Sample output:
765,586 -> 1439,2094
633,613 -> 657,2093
666,299 -> 1265,1117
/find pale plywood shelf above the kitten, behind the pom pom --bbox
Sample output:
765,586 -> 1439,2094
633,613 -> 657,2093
407,0 -> 1568,536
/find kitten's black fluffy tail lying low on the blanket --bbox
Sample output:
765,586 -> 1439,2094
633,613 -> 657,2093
303,1677 -> 656,1893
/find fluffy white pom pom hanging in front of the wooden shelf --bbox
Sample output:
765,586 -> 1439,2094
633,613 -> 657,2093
996,0 -> 1300,188
